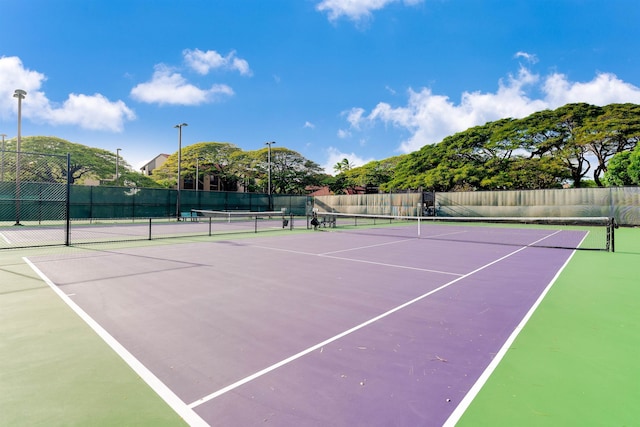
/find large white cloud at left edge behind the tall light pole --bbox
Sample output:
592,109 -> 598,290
0,56 -> 135,132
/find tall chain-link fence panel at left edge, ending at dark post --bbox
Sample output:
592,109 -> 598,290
0,151 -> 70,249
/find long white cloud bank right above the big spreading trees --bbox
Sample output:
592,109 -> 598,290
348,67 -> 640,153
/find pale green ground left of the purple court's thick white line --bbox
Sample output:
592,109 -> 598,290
0,242 -> 186,426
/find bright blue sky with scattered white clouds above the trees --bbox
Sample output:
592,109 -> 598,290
0,0 -> 640,172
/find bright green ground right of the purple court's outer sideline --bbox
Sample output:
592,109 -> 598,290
457,228 -> 640,427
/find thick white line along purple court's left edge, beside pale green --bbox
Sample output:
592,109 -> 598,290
22,257 -> 209,426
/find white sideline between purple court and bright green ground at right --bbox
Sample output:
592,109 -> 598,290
443,250 -> 576,427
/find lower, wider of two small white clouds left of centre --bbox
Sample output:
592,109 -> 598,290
131,64 -> 234,105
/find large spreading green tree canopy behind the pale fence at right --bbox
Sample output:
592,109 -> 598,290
381,103 -> 640,191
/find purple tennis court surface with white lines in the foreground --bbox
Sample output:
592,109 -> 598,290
15,222 -> 605,426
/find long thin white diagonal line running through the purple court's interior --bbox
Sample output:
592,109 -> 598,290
189,236 -> 549,408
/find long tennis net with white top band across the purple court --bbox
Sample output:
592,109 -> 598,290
309,212 -> 616,251
